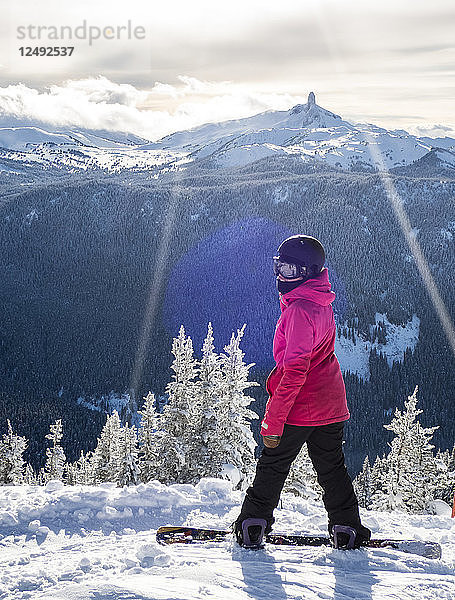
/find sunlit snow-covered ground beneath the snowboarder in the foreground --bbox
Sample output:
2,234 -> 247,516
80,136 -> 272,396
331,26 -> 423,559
0,479 -> 455,600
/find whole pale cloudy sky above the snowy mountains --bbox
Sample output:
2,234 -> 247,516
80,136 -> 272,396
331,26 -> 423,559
0,0 -> 455,139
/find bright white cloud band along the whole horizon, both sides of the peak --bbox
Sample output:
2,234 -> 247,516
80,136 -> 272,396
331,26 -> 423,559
0,75 -> 455,140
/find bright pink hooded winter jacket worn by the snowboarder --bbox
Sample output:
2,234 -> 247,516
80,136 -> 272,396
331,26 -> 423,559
261,268 -> 350,435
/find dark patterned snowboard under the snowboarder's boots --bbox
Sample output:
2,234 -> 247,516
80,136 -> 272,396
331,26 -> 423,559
156,526 -> 441,558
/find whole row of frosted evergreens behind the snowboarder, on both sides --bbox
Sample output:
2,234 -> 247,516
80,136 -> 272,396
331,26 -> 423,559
0,323 -> 455,513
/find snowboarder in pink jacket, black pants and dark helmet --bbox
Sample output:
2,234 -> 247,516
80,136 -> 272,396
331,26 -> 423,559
234,235 -> 371,548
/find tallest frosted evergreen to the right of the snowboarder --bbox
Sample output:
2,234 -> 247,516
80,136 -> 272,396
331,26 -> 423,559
372,387 -> 438,513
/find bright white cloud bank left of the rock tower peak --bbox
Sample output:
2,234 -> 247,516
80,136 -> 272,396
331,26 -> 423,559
0,75 -> 304,140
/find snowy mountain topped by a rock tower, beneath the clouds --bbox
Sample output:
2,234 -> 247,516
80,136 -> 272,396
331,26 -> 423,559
147,92 -> 442,169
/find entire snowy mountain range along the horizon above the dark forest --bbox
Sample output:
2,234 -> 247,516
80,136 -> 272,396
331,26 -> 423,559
0,92 -> 455,176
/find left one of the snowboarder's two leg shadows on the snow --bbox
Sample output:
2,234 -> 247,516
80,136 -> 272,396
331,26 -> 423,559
232,545 -> 288,600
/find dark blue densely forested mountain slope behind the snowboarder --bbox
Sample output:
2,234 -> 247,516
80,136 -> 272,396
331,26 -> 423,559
0,157 -> 455,467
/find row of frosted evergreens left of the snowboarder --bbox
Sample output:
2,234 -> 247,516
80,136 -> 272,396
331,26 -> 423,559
0,323 -> 258,487
